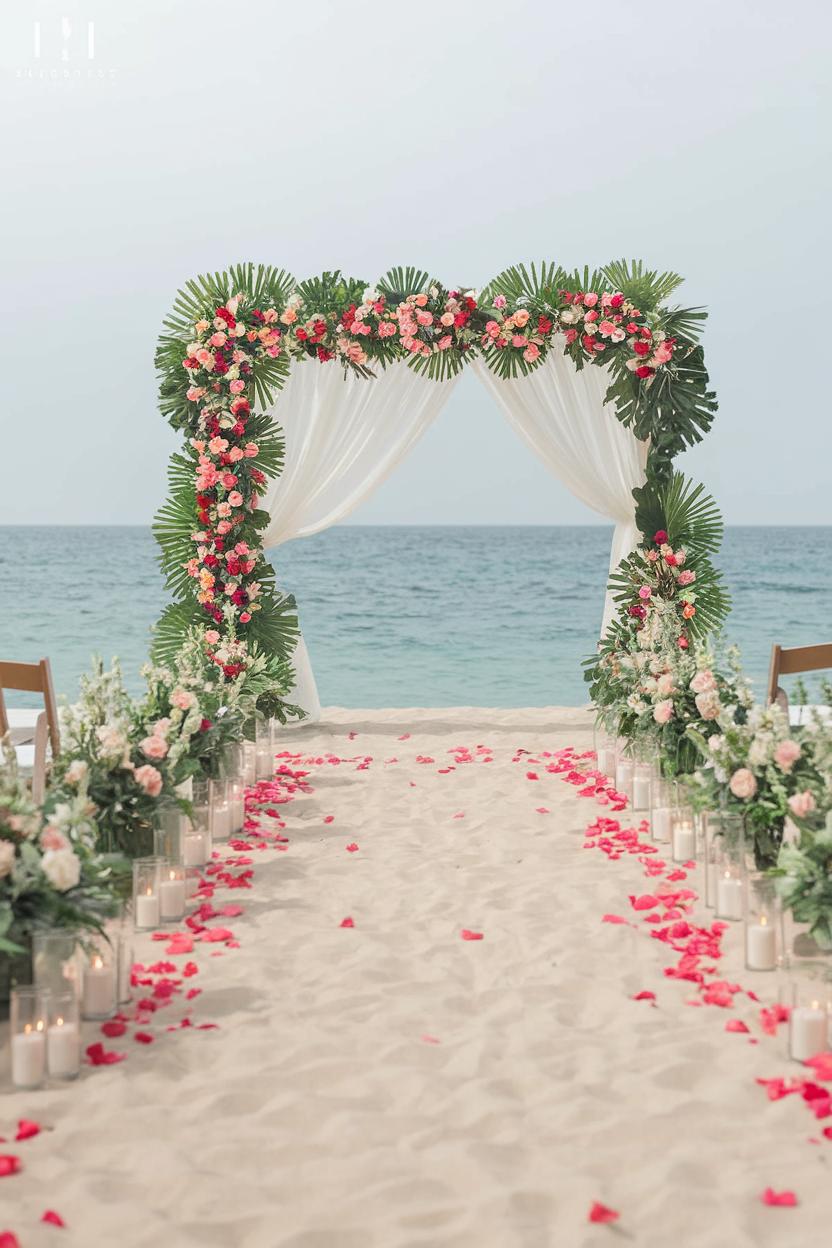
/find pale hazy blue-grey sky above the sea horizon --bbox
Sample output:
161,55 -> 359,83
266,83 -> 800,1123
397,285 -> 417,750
0,0 -> 832,524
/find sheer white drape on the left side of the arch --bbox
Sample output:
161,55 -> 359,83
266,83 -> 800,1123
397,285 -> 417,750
262,361 -> 457,723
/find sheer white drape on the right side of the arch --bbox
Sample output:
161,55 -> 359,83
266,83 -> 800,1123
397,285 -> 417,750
474,347 -> 647,634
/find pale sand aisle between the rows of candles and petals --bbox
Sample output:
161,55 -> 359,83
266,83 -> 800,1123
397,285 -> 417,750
0,709 -> 832,1248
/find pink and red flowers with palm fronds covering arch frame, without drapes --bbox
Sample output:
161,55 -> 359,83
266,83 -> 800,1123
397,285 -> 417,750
155,261 -> 728,718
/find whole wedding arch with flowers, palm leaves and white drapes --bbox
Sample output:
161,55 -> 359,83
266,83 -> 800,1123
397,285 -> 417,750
155,261 -> 727,719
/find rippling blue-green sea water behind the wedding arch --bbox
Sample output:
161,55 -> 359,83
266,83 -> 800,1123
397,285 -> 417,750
0,525 -> 832,706
